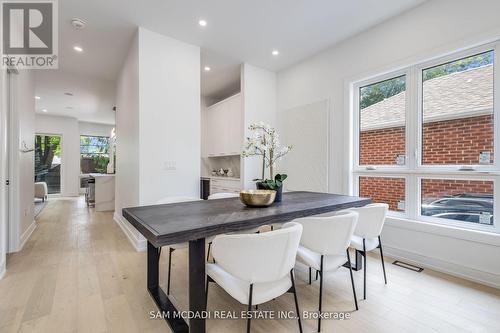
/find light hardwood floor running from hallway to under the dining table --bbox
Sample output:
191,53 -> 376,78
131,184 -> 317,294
0,198 -> 500,333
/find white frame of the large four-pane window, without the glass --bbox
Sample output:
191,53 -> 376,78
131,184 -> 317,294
349,40 -> 500,233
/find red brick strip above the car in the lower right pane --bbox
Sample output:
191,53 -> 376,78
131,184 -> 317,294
422,179 -> 493,199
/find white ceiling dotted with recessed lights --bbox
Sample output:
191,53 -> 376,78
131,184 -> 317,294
37,0 -> 425,122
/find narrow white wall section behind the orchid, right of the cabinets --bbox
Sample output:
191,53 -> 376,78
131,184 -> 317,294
241,64 -> 277,188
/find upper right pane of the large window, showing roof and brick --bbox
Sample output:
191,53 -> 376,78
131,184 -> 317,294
422,51 -> 494,165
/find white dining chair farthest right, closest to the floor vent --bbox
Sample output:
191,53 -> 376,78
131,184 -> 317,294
351,203 -> 389,299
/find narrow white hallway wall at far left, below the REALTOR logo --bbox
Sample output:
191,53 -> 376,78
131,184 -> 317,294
9,70 -> 35,252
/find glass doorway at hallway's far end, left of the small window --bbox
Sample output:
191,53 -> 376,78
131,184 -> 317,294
35,134 -> 62,194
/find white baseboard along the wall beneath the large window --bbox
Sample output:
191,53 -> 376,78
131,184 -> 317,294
384,244 -> 500,288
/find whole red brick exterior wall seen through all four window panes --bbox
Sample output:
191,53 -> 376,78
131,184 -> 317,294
359,115 -> 494,211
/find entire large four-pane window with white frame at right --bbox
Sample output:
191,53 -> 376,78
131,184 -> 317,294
353,43 -> 500,232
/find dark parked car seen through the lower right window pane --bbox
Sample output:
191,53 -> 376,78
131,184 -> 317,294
421,193 -> 493,224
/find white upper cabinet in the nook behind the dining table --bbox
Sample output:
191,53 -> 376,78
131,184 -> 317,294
202,94 -> 243,157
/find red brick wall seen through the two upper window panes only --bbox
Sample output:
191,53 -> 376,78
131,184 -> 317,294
360,115 -> 494,165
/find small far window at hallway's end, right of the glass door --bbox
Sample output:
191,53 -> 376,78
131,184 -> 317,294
80,135 -> 110,174
